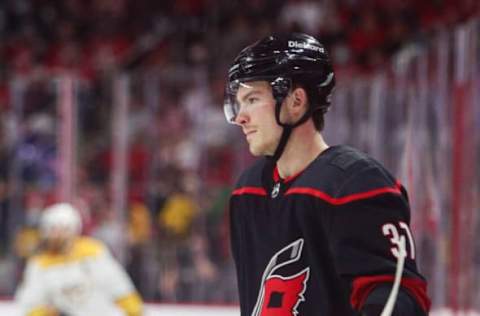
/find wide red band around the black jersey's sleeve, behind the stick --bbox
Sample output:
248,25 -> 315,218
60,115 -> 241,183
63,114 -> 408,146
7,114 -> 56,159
350,275 -> 431,314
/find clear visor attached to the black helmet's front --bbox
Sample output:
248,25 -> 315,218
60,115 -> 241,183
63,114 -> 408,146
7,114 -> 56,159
223,77 -> 291,124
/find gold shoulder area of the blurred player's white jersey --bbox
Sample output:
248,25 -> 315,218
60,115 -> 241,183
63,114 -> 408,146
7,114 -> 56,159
31,236 -> 107,268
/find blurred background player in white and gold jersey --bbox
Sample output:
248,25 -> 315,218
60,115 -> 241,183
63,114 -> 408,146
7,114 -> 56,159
15,203 -> 143,316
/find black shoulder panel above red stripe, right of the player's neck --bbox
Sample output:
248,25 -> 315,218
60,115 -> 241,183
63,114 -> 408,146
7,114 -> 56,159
295,146 -> 398,198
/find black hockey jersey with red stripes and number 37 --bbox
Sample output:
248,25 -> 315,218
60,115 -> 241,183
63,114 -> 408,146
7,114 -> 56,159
230,146 -> 430,316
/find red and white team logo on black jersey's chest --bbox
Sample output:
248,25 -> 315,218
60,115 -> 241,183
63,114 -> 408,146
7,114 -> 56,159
252,239 -> 310,316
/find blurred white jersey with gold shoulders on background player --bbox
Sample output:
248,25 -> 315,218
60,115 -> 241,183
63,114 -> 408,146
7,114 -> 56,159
15,237 -> 142,316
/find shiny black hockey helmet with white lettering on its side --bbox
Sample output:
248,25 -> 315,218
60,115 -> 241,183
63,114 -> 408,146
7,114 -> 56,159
224,33 -> 335,128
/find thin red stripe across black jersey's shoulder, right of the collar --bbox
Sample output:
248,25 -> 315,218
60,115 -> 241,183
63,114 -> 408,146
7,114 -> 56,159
285,182 -> 402,205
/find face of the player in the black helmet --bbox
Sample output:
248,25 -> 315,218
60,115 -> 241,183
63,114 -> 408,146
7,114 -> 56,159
235,81 -> 282,156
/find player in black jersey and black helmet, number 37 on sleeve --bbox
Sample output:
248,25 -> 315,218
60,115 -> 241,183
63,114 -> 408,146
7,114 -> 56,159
224,33 -> 430,316
